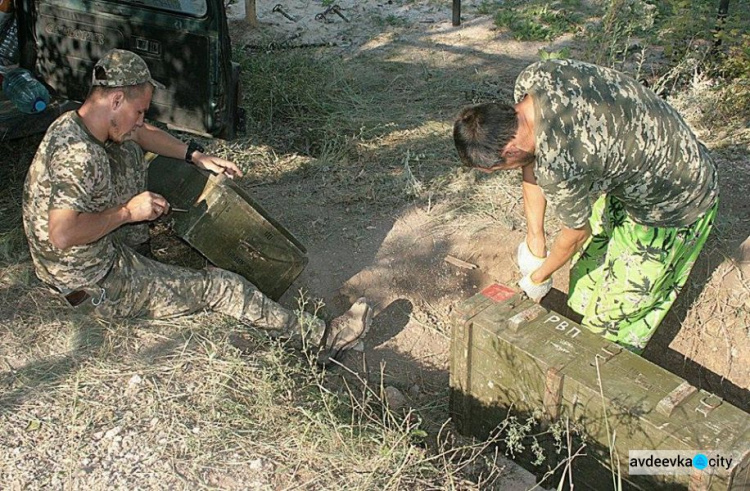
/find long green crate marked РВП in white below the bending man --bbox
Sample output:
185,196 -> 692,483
450,284 -> 750,491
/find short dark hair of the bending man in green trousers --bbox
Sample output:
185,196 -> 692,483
453,102 -> 518,167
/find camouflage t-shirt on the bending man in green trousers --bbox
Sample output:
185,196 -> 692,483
515,60 -> 718,228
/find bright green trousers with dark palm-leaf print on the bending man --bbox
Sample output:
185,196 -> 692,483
568,196 -> 718,353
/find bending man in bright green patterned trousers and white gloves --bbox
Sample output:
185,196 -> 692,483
453,60 -> 718,353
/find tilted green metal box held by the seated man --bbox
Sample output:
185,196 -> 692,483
148,157 -> 307,300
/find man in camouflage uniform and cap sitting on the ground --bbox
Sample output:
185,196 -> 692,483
23,50 -> 372,362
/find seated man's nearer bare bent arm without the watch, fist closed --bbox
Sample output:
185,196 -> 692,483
49,191 -> 169,250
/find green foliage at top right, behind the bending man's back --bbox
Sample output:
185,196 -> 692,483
479,0 -> 750,123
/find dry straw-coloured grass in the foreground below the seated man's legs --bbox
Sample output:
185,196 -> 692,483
0,288 -> 516,489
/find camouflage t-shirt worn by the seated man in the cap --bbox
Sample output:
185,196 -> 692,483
23,111 -> 145,292
